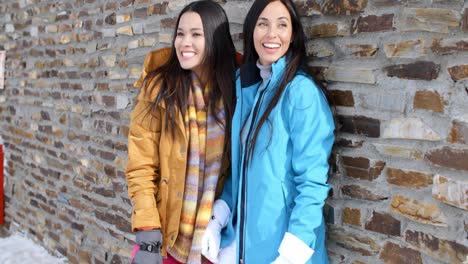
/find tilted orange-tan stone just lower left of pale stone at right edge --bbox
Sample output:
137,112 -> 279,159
390,195 -> 448,226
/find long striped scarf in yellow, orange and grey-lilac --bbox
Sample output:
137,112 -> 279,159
168,73 -> 226,264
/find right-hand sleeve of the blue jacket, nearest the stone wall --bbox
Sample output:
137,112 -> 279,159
287,76 -> 335,249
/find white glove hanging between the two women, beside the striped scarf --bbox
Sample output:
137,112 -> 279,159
201,199 -> 231,263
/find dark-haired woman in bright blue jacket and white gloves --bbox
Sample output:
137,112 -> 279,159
202,0 -> 334,264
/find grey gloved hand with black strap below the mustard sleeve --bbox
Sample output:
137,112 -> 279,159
132,229 -> 162,264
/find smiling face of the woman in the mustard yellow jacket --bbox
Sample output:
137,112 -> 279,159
174,12 -> 205,77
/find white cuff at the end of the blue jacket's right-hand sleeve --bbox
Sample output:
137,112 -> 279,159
278,232 -> 314,264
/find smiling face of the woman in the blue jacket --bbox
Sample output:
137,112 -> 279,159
253,1 -> 293,65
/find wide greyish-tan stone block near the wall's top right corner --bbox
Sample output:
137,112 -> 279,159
400,8 -> 461,33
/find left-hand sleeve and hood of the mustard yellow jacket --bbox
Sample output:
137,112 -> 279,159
126,48 -> 170,231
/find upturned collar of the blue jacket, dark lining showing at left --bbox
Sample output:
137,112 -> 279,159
240,56 -> 286,88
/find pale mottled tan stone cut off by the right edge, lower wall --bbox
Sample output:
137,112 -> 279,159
432,175 -> 468,211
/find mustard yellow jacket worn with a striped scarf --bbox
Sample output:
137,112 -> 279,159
126,48 -> 229,256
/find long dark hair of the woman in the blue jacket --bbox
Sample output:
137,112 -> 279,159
243,0 -> 328,161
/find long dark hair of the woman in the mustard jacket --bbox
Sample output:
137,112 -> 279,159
144,0 -> 236,159
